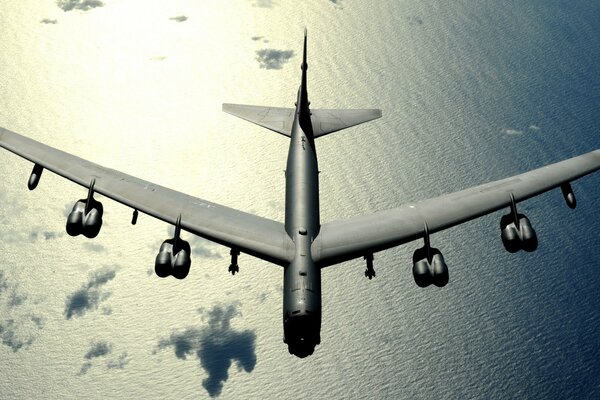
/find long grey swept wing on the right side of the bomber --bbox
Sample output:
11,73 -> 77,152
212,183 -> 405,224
312,150 -> 600,267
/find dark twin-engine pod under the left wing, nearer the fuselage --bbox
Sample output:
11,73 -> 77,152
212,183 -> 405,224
154,238 -> 192,279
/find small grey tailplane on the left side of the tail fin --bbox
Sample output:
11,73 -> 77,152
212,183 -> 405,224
223,103 -> 295,137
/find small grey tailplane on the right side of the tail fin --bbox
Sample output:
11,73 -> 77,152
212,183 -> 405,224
310,109 -> 381,138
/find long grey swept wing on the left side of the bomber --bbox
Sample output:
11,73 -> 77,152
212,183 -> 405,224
0,128 -> 293,265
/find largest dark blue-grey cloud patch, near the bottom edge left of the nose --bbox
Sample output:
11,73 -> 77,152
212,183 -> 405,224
158,302 -> 256,397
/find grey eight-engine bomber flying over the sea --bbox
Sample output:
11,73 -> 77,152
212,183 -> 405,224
0,30 -> 600,358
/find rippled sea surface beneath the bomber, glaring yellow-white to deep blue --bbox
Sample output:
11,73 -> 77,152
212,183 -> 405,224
0,0 -> 600,399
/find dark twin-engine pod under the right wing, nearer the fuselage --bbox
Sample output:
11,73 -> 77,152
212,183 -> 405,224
413,246 -> 450,287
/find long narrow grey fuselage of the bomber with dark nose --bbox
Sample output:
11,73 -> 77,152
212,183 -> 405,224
283,81 -> 321,357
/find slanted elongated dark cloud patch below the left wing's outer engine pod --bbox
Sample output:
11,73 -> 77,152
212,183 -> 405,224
64,267 -> 117,319
